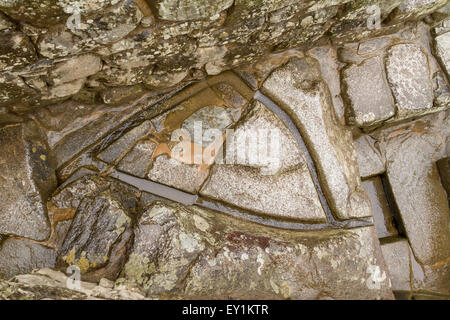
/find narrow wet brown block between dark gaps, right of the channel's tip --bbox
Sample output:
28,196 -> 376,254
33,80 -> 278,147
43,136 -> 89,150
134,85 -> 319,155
363,177 -> 398,238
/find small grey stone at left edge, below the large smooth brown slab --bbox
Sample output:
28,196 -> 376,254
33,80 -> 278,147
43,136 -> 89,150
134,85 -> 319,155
0,239 -> 56,279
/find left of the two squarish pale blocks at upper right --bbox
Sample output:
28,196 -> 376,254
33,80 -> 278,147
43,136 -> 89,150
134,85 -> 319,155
343,57 -> 395,127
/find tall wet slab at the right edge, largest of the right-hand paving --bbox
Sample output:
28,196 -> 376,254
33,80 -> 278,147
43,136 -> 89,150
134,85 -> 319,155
381,112 -> 450,265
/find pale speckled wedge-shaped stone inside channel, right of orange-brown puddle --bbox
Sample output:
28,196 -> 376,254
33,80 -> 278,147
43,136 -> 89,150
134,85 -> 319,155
201,102 -> 326,222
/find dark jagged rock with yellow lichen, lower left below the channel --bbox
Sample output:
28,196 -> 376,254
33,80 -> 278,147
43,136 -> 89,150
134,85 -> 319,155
50,176 -> 137,282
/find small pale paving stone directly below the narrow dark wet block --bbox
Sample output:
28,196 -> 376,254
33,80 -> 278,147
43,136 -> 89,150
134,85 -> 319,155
381,239 -> 411,291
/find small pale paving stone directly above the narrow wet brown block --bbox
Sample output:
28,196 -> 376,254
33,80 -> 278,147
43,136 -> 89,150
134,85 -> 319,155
354,135 -> 386,178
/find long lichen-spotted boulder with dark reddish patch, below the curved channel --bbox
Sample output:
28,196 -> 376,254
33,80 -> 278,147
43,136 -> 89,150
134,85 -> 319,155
116,202 -> 392,299
